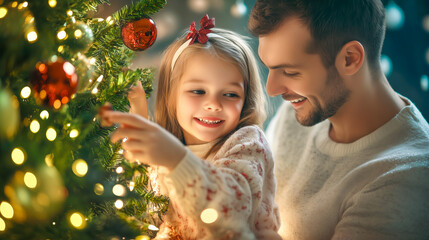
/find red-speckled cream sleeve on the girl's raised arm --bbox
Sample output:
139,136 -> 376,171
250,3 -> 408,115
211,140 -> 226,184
159,126 -> 278,239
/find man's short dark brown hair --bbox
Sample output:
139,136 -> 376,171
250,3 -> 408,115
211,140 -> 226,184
249,0 -> 386,71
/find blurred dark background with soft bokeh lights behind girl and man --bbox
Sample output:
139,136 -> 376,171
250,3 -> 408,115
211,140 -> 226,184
96,0 -> 429,126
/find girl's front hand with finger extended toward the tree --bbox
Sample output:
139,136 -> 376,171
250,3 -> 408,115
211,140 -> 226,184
102,111 -> 186,171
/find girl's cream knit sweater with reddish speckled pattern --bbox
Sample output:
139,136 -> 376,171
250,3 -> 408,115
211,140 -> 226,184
152,126 -> 280,240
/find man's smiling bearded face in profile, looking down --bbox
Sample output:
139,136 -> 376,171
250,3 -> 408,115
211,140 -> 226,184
259,18 -> 350,126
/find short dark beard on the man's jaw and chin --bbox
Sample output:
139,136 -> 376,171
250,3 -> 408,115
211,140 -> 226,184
296,67 -> 350,126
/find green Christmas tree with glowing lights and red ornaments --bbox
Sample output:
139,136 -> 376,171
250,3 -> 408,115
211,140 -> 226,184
0,0 -> 168,240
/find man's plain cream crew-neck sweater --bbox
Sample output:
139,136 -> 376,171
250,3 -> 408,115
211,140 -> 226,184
267,99 -> 429,240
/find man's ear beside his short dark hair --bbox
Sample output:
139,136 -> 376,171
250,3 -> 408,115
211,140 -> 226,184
335,41 -> 365,76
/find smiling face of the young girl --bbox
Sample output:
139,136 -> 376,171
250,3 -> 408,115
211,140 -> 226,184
176,53 -> 244,145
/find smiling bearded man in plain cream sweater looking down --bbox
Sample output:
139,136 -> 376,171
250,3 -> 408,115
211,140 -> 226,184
249,0 -> 429,240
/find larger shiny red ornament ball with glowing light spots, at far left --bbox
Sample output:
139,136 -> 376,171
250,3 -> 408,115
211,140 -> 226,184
31,59 -> 78,109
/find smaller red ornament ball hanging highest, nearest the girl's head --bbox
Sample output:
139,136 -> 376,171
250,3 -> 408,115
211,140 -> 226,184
121,17 -> 157,51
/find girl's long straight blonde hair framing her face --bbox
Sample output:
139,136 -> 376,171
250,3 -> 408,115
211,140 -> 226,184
155,28 -> 266,157
